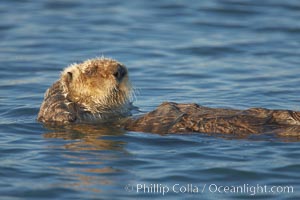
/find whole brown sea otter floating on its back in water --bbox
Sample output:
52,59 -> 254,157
37,58 -> 300,137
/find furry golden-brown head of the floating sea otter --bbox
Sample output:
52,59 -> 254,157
60,58 -> 131,114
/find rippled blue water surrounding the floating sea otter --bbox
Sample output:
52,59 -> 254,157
0,0 -> 300,200
